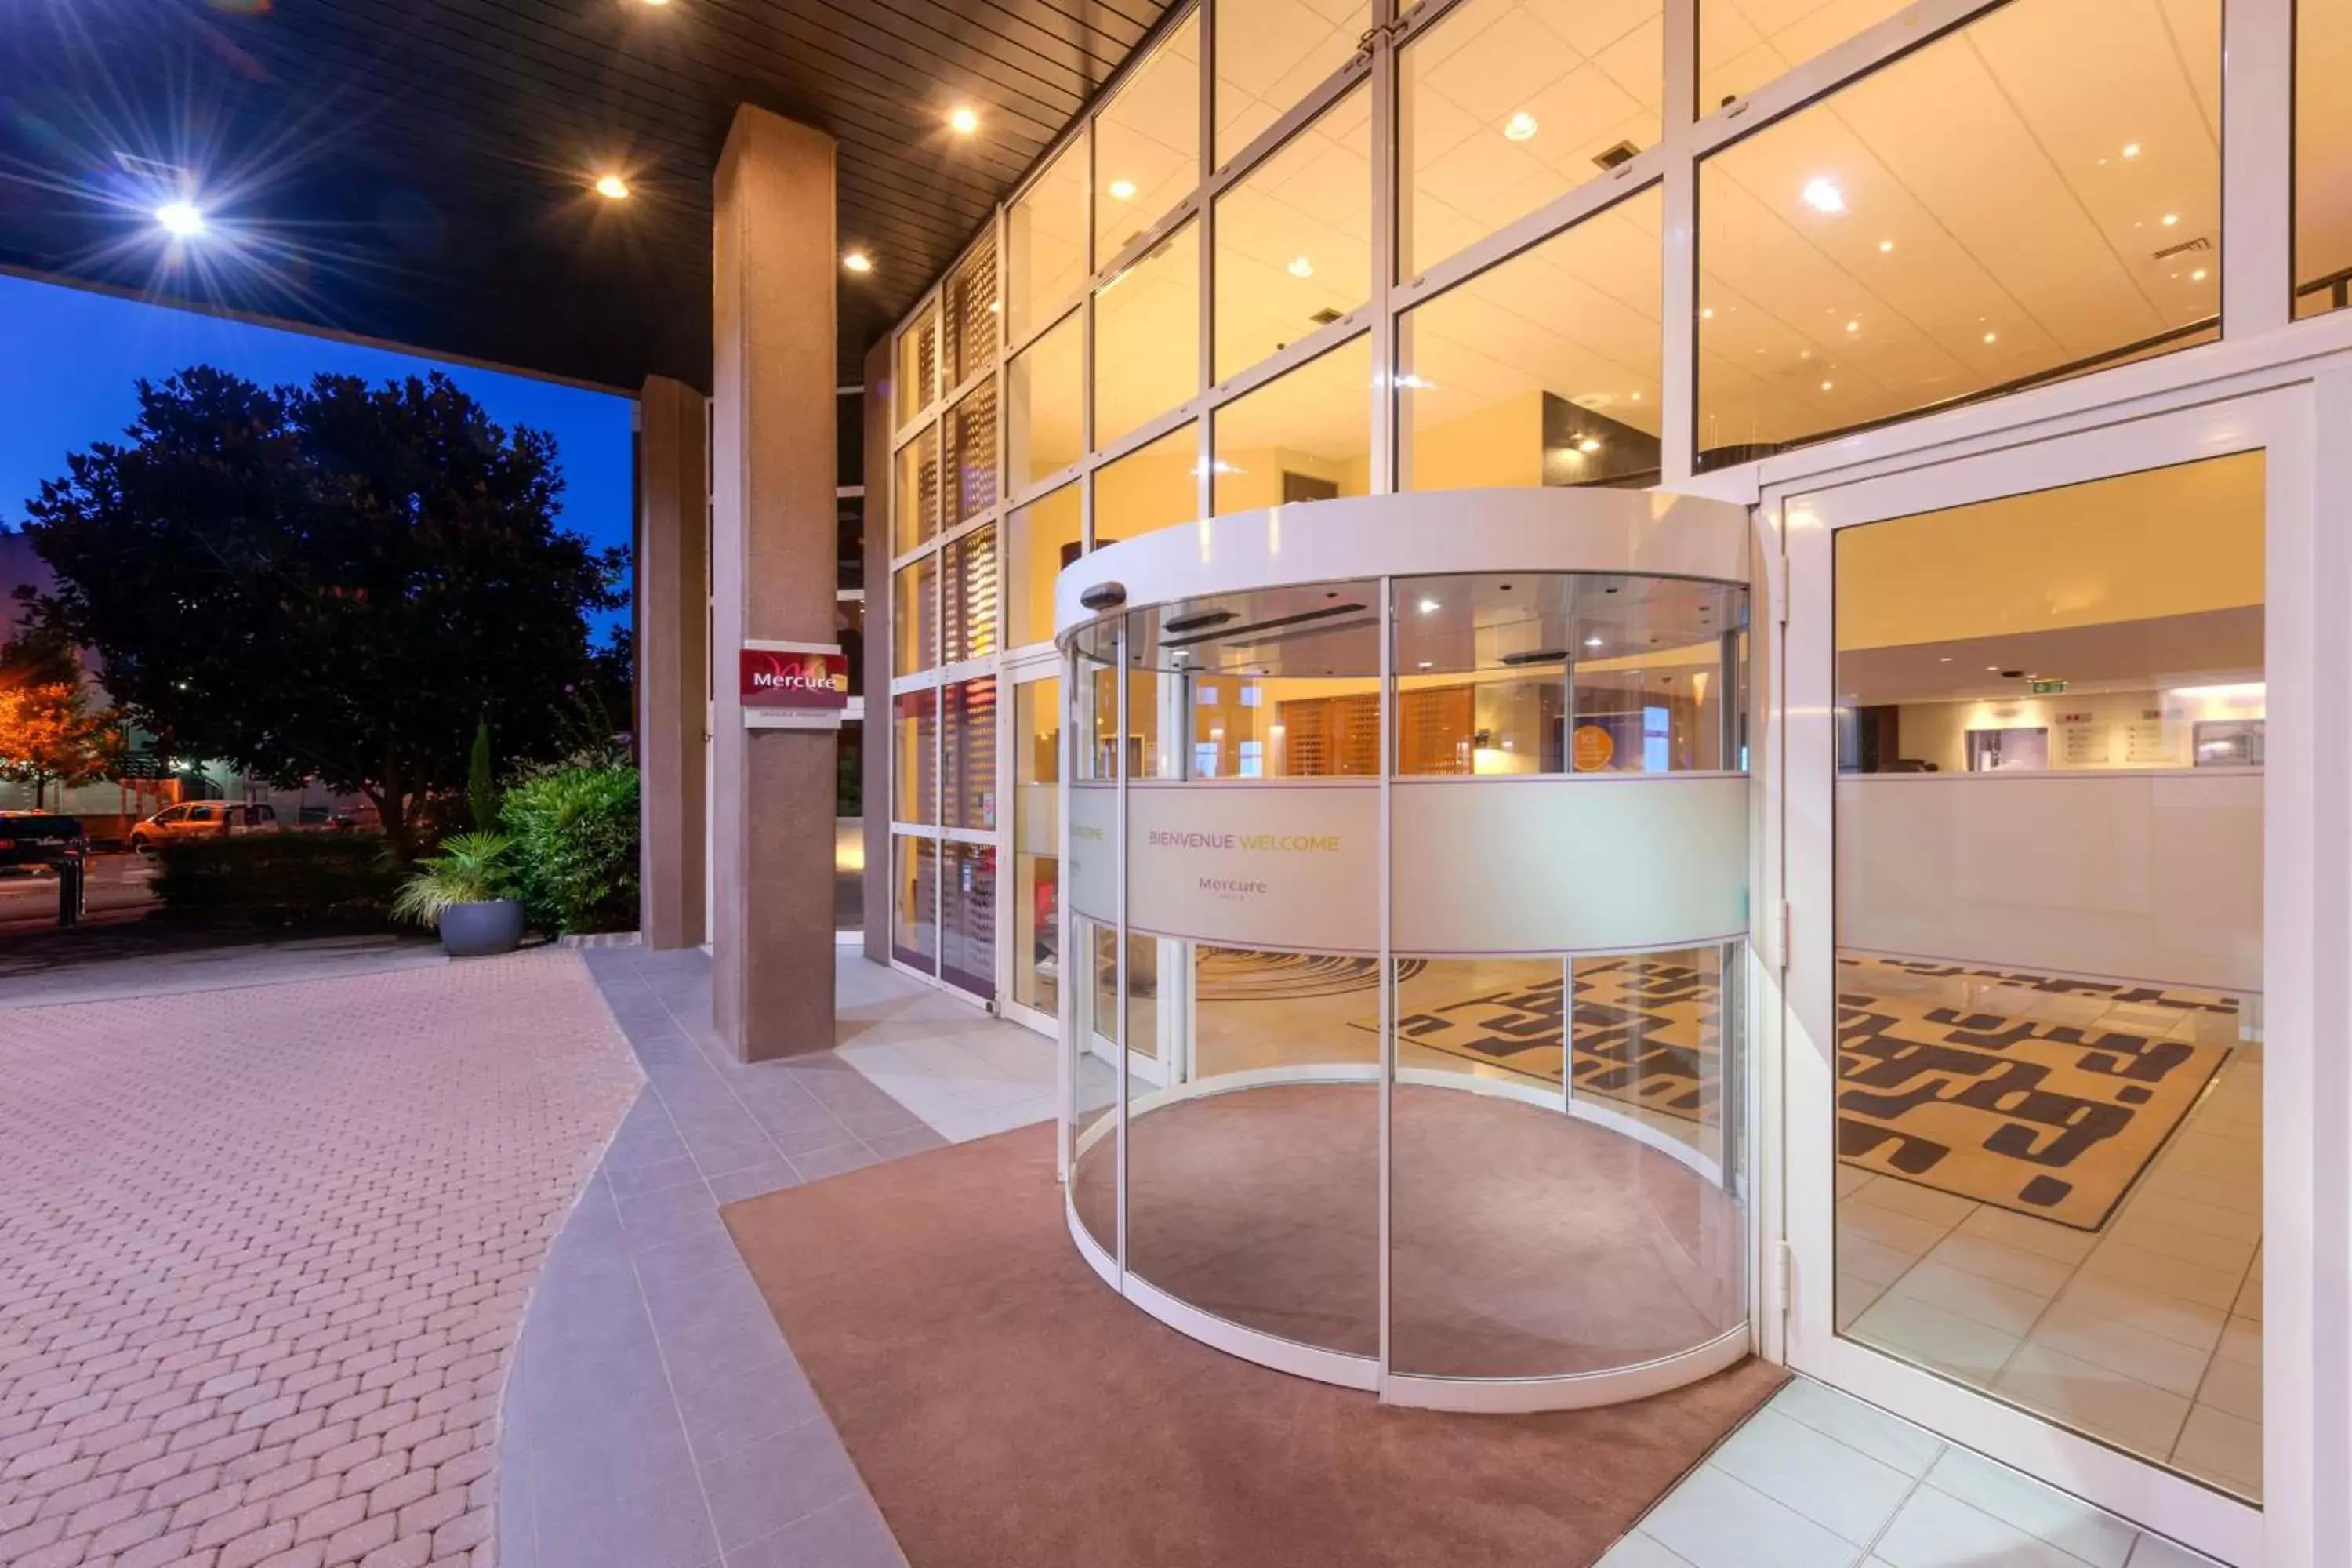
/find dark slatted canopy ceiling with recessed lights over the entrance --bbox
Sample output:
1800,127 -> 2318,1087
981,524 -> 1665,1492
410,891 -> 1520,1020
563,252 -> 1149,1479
0,0 -> 1167,390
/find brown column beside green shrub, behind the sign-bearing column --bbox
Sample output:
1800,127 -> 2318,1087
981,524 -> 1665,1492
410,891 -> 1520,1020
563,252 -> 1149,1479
633,376 -> 710,947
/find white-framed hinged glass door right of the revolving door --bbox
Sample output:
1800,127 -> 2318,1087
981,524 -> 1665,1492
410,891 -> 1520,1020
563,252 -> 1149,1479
1766,395 -> 2310,1563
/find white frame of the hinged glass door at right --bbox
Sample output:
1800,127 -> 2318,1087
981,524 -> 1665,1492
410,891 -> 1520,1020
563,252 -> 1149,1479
1759,383 -> 2314,1568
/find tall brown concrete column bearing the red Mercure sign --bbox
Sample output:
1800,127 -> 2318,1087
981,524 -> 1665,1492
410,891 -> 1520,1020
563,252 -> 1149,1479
710,106 -> 837,1062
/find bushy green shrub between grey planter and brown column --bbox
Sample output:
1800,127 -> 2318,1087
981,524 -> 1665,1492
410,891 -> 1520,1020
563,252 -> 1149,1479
503,767 -> 637,931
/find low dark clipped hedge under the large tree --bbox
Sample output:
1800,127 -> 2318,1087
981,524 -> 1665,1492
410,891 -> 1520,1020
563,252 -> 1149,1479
151,832 -> 400,926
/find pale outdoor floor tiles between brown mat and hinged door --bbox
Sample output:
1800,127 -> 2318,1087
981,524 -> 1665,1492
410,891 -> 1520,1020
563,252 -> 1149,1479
1599,1377 -> 2209,1568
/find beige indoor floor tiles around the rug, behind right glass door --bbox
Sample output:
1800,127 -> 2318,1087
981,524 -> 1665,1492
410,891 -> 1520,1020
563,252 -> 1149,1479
1837,982 -> 2263,1497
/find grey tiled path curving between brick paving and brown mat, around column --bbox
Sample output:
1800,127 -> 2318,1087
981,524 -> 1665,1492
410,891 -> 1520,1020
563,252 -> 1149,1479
499,947 -> 1054,1568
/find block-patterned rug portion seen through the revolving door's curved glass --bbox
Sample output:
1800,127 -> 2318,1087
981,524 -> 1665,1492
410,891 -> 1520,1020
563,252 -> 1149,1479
1350,959 -> 1722,1121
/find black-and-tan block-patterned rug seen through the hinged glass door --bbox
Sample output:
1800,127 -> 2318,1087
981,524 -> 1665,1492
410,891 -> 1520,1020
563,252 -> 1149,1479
1837,956 -> 2237,1232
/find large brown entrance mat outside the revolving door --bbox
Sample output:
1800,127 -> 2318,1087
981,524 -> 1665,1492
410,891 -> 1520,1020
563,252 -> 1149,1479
724,1123 -> 1783,1568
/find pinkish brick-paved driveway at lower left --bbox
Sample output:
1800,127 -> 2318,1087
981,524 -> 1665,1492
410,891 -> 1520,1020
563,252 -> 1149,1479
0,949 -> 640,1568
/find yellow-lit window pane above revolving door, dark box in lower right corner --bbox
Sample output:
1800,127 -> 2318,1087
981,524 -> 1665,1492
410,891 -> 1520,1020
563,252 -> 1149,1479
1397,188 -> 1663,489
